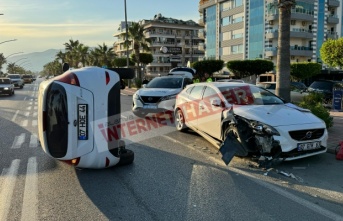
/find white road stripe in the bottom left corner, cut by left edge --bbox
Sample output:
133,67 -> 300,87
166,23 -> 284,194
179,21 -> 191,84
0,159 -> 20,220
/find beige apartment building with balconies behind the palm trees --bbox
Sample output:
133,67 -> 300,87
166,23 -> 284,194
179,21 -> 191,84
114,14 -> 204,77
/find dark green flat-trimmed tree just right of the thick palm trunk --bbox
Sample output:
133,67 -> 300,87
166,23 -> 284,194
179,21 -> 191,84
291,62 -> 322,81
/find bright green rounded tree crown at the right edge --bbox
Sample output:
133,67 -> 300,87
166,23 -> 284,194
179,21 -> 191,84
320,38 -> 343,67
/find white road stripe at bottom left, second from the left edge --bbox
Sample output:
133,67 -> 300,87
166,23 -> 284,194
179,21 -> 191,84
21,157 -> 38,220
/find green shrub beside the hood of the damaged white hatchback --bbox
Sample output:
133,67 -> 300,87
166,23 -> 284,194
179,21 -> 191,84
299,93 -> 333,128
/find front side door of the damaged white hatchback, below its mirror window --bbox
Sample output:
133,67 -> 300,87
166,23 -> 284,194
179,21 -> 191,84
197,86 -> 223,139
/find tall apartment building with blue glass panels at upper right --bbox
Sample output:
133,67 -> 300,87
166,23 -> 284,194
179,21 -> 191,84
199,0 -> 343,64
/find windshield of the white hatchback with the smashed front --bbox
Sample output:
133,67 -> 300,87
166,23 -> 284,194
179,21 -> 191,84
219,85 -> 284,105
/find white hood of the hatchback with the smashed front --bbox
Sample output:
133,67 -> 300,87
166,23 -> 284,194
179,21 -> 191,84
233,104 -> 323,127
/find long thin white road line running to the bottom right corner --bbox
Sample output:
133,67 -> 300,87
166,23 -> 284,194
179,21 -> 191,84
162,135 -> 343,220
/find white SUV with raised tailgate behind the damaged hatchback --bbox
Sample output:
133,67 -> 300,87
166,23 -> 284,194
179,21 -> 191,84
132,75 -> 193,117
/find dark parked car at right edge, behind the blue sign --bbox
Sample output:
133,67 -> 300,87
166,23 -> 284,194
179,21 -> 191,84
308,80 -> 343,107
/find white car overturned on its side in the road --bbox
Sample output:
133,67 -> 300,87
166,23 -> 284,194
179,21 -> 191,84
38,65 -> 134,168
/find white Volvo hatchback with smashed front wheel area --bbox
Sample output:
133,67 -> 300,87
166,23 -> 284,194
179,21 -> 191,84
174,82 -> 328,164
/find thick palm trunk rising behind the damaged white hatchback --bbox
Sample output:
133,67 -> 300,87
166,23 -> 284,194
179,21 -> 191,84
275,0 -> 296,102
